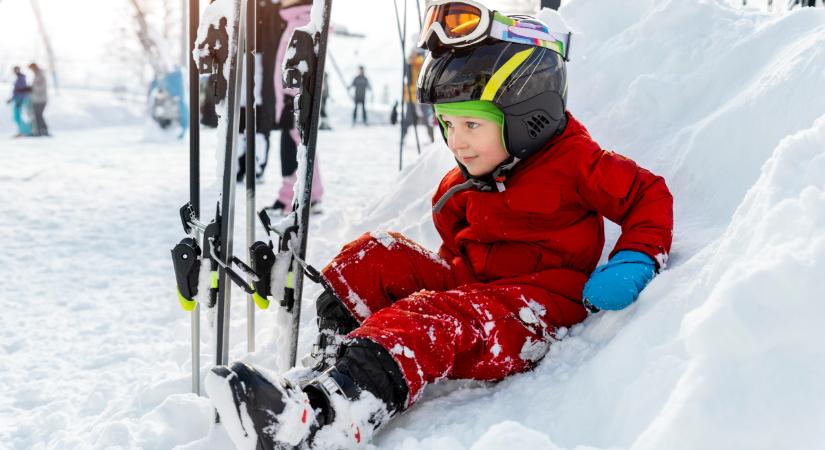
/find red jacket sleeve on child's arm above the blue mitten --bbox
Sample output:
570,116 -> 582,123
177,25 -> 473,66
578,143 -> 673,267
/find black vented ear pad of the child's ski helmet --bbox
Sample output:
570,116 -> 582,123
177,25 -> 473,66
501,91 -> 566,159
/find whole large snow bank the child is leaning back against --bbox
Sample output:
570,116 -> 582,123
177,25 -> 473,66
318,0 -> 825,449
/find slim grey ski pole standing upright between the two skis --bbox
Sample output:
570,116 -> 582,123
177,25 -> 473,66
239,0 -> 257,352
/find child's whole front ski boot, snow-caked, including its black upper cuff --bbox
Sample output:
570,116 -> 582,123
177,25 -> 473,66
206,340 -> 409,450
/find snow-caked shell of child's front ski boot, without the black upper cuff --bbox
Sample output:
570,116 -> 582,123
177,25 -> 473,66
206,362 -> 391,450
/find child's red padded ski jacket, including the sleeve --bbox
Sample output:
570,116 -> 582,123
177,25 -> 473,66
433,113 -> 673,310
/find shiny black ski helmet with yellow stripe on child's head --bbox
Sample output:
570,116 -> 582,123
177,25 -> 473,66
417,16 -> 567,159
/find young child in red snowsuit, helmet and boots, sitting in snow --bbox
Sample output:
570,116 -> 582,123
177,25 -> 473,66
206,4 -> 673,449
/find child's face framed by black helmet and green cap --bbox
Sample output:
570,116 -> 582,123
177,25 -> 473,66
441,114 -> 510,176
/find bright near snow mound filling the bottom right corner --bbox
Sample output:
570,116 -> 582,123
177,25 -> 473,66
638,115 -> 825,449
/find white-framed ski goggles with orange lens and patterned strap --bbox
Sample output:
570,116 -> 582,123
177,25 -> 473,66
418,0 -> 571,61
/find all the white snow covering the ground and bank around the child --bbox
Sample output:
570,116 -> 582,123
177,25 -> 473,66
0,0 -> 825,450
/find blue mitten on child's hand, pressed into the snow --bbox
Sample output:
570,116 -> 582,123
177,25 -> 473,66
582,250 -> 656,312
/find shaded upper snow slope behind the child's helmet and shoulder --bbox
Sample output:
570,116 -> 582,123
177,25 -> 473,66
564,0 -> 825,232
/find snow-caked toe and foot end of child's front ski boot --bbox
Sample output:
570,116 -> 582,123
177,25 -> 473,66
205,362 -> 318,450
